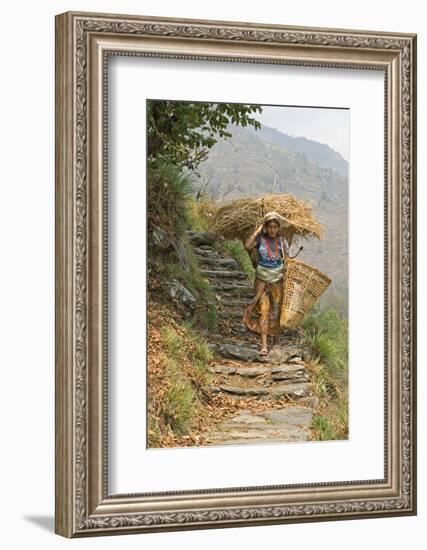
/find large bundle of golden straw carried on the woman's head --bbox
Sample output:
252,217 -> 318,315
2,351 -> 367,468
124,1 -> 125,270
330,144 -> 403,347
211,195 -> 324,244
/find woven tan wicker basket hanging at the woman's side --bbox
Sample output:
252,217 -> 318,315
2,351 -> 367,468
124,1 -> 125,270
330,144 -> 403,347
280,258 -> 331,328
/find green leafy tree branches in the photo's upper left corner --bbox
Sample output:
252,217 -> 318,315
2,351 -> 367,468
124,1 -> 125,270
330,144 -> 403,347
147,100 -> 262,170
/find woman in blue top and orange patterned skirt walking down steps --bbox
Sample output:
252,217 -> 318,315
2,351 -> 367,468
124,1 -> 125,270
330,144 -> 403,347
243,212 -> 289,355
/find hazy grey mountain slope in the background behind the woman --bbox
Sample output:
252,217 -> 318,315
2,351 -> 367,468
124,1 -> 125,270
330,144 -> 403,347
189,126 -> 348,316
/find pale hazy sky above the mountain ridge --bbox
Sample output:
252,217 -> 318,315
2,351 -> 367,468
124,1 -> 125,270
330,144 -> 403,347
254,106 -> 350,161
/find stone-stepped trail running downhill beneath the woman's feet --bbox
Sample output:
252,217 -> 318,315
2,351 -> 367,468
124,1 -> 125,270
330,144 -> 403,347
189,232 -> 317,445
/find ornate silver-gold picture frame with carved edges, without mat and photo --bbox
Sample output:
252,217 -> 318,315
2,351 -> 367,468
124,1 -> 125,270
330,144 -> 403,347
55,12 -> 416,538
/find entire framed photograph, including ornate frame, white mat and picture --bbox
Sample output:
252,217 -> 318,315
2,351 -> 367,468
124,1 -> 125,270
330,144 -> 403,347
55,12 -> 416,537
